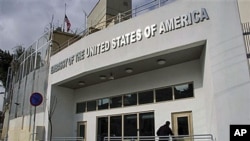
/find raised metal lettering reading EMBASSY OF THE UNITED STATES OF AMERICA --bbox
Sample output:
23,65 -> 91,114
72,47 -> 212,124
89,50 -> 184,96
51,8 -> 209,74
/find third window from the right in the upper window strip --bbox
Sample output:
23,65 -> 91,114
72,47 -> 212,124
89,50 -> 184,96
138,90 -> 154,104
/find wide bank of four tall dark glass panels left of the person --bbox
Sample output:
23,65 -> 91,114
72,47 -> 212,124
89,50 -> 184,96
97,112 -> 155,141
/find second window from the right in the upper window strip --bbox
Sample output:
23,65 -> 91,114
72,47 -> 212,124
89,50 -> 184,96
155,87 -> 173,102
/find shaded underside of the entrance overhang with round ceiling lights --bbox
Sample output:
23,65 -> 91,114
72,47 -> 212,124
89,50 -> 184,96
55,41 -> 206,89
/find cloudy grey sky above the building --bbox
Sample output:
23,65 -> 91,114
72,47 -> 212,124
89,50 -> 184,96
0,0 -> 153,52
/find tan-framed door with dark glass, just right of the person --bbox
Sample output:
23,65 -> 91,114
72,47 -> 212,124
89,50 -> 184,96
172,111 -> 193,141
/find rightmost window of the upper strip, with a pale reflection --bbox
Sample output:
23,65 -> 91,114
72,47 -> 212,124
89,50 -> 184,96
174,83 -> 194,99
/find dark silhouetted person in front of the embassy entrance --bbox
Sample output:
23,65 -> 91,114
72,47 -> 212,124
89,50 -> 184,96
156,121 -> 174,141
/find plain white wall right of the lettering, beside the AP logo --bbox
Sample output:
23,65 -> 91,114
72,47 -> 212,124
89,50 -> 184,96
204,0 -> 250,140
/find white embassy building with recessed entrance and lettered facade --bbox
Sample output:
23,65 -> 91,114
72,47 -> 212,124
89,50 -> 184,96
2,0 -> 250,141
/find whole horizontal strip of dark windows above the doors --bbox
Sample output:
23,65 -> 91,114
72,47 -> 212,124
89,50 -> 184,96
77,82 -> 194,113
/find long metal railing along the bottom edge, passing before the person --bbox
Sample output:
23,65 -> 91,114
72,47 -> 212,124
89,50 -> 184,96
103,134 -> 214,141
